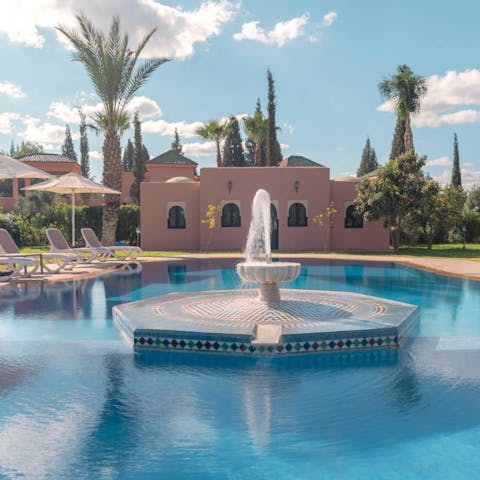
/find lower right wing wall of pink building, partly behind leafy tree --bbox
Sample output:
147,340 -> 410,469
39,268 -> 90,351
330,181 -> 390,250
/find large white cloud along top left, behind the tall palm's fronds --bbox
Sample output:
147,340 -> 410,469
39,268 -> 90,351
0,0 -> 238,59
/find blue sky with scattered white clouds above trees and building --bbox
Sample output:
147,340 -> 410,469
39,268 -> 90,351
0,0 -> 480,188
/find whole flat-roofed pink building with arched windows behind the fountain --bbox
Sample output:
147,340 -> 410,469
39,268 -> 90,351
141,151 -> 389,251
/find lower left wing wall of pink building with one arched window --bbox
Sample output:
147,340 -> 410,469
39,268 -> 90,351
140,182 -> 200,250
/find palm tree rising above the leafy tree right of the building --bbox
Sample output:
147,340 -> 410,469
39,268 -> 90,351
378,65 -> 427,152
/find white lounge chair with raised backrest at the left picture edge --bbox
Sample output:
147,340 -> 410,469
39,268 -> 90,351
0,228 -> 79,273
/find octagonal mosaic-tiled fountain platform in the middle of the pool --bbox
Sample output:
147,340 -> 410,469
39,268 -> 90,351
113,289 -> 420,356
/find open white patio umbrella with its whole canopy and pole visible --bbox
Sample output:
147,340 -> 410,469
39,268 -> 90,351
24,172 -> 120,246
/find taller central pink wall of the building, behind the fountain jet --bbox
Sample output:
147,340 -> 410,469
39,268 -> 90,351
200,167 -> 330,251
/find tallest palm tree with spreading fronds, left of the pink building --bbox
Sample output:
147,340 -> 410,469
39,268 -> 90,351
57,15 -> 168,245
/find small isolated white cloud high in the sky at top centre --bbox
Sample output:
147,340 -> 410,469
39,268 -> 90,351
233,13 -> 309,47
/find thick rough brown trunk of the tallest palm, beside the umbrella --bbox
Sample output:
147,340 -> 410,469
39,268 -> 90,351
102,129 -> 122,245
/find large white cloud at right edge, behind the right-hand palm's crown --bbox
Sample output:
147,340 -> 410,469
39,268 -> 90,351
378,69 -> 480,128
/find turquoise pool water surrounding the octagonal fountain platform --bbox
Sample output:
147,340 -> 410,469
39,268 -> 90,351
0,259 -> 480,479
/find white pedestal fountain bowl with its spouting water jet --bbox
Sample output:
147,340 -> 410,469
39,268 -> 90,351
237,189 -> 300,303
